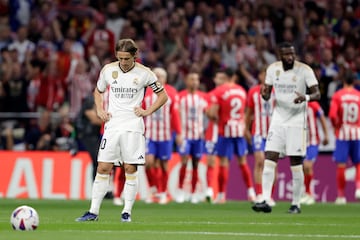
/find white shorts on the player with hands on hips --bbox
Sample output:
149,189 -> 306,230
97,130 -> 145,165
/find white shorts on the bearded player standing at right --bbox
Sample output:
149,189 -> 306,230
265,125 -> 306,156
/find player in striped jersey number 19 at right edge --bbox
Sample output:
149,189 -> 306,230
329,72 -> 360,204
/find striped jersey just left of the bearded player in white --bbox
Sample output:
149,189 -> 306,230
247,85 -> 274,138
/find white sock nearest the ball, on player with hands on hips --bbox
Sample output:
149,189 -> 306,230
90,173 -> 110,215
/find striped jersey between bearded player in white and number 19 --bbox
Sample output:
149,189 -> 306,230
307,101 -> 324,145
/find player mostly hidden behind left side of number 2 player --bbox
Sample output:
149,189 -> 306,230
205,70 -> 226,202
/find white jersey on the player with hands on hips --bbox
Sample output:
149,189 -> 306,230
97,61 -> 162,133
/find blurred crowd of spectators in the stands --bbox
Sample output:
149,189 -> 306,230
0,0 -> 360,156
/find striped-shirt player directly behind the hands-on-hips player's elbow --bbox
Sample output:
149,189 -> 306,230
143,68 -> 182,204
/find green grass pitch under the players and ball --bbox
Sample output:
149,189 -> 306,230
0,199 -> 360,240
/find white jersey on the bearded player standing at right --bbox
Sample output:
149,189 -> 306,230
265,61 -> 318,126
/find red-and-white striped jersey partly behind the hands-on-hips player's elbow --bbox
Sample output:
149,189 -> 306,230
142,84 -> 181,141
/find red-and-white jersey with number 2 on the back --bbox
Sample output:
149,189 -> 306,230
211,84 -> 247,138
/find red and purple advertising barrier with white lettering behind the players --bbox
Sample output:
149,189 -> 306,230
0,151 -> 355,202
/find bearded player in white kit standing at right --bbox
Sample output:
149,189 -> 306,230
252,43 -> 320,213
